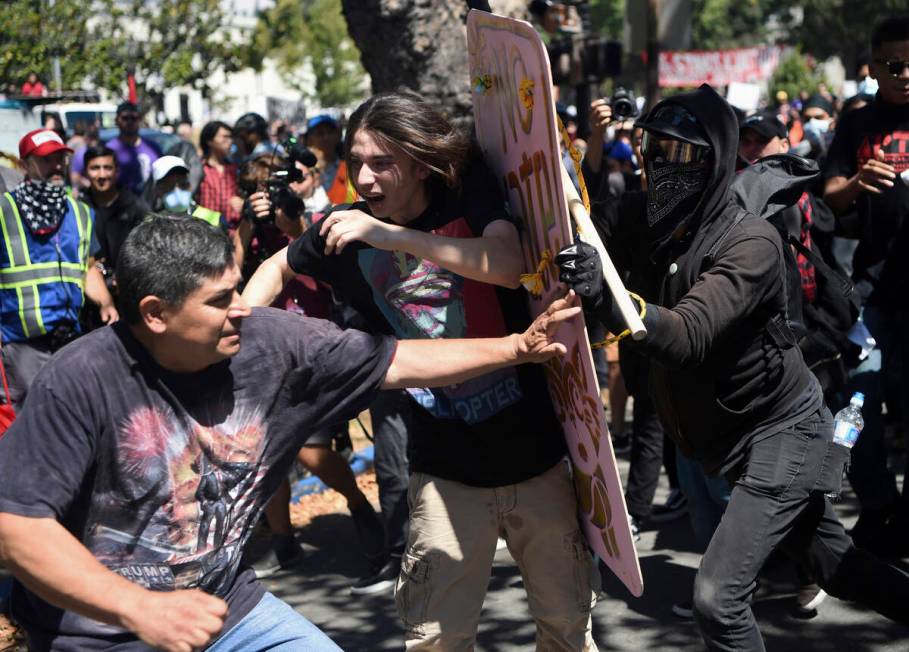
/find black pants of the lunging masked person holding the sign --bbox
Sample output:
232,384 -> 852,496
694,408 -> 909,651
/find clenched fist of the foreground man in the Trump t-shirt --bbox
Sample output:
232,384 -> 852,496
123,589 -> 227,652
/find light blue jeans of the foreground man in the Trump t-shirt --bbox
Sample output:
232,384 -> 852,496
208,593 -> 341,652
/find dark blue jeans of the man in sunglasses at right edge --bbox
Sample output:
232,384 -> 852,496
848,306 -> 909,510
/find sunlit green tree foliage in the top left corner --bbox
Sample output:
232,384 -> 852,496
0,0 -> 243,108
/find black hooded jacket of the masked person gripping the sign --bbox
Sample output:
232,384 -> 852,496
592,85 -> 820,471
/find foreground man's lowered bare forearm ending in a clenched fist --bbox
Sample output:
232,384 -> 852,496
0,512 -> 227,652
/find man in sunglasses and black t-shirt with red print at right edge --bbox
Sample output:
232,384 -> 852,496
824,15 -> 909,555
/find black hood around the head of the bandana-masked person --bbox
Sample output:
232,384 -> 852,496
651,84 -> 739,250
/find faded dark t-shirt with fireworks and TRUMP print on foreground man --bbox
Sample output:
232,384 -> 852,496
0,308 -> 396,651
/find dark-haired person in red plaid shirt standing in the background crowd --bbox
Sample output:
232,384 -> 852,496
196,120 -> 243,231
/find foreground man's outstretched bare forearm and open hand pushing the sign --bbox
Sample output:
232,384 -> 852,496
382,292 -> 581,389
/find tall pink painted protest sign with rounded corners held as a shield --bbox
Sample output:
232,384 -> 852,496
467,11 -> 644,596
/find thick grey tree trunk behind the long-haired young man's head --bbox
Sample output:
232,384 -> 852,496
341,0 -> 471,124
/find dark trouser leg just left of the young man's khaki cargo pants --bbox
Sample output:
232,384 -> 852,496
369,390 -> 410,557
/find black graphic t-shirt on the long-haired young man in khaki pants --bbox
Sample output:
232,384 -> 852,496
287,162 -> 565,487
